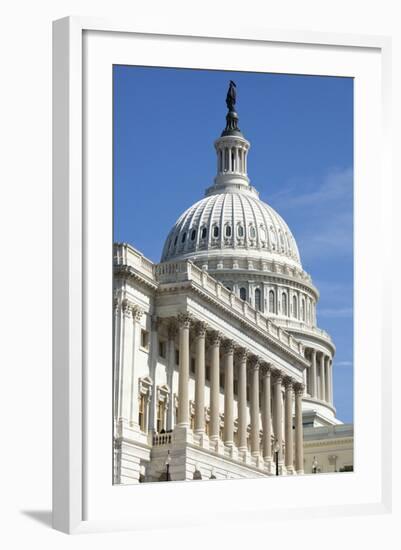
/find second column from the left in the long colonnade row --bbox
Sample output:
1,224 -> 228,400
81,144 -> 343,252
194,322 -> 207,434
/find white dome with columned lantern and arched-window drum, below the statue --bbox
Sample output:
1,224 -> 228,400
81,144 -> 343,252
161,82 -> 318,327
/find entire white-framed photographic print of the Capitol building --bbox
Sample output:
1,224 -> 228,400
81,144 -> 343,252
53,18 -> 390,532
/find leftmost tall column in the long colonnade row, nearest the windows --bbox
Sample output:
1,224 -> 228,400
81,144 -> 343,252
178,313 -> 191,428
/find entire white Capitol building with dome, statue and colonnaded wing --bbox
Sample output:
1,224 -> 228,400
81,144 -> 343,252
114,83 -> 352,484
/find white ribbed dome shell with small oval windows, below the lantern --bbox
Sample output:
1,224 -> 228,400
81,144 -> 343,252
162,189 -> 301,267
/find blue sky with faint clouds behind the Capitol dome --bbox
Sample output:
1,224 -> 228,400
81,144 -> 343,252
113,66 -> 353,422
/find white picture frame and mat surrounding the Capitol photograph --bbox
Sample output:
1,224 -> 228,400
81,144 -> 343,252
53,17 -> 392,533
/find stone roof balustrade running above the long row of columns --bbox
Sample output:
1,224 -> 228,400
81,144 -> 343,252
155,261 -> 304,356
